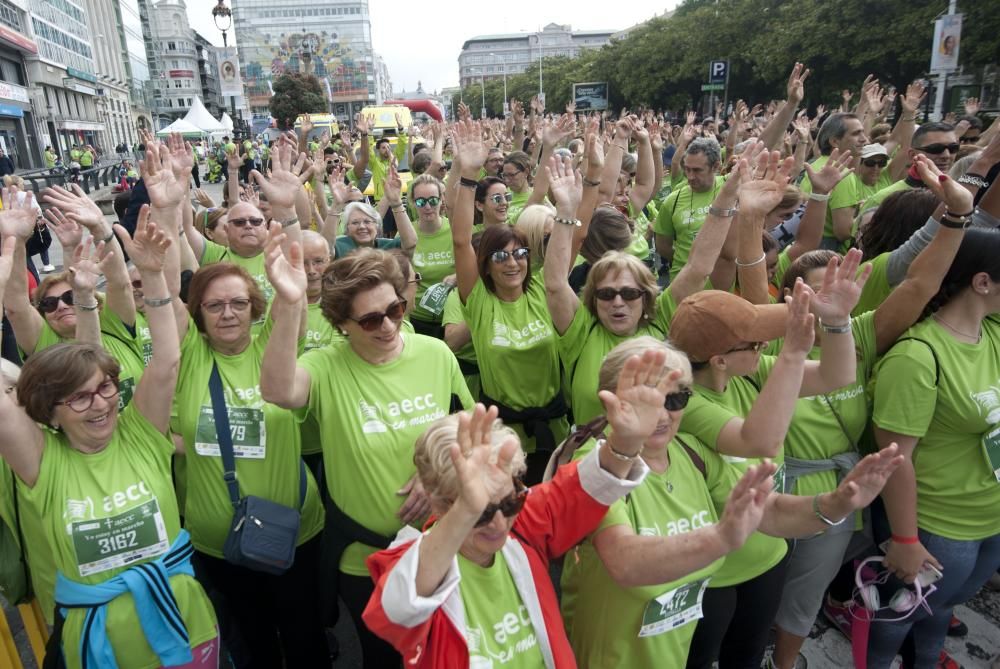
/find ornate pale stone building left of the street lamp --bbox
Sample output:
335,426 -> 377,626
149,0 -> 201,129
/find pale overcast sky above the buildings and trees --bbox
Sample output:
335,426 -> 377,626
187,0 -> 680,93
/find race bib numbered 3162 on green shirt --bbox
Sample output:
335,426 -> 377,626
70,498 -> 170,576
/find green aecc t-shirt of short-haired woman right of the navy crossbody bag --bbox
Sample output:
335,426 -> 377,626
298,332 -> 472,576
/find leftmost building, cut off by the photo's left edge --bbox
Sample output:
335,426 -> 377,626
0,0 -> 45,169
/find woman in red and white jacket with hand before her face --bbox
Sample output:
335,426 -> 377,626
364,348 -> 675,669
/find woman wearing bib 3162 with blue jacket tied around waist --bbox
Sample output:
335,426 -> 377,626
0,206 -> 219,669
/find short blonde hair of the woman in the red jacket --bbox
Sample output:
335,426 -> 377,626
413,413 -> 528,500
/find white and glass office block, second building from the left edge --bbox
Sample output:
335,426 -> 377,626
25,0 -> 105,157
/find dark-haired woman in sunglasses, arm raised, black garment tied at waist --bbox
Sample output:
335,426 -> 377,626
451,124 -> 576,483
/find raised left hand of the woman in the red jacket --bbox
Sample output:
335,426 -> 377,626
598,350 -> 681,455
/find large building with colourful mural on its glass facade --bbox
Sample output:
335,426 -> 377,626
233,0 -> 377,127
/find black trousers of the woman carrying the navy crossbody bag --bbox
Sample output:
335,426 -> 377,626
195,536 -> 330,669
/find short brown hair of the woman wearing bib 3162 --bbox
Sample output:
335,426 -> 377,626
17,343 -> 121,425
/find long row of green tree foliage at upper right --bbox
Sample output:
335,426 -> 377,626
456,0 -> 1000,115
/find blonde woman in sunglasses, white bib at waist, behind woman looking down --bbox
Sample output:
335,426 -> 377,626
410,174 -> 455,339
